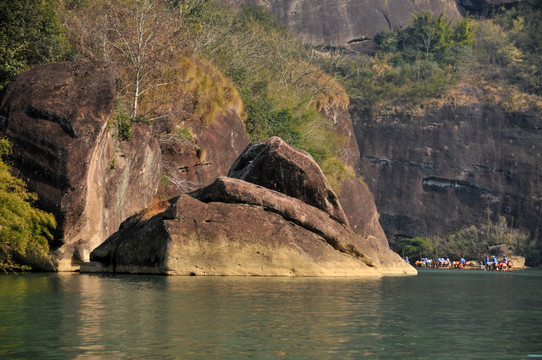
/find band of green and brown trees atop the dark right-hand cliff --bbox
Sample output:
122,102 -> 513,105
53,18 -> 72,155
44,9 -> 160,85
327,2 -> 542,112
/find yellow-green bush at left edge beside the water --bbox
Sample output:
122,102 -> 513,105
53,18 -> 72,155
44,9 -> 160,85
0,139 -> 56,272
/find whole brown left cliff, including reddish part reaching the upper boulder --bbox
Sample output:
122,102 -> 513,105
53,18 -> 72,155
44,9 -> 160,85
0,63 -> 248,271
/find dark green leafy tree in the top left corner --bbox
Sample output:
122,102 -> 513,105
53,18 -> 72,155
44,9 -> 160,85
0,0 -> 70,90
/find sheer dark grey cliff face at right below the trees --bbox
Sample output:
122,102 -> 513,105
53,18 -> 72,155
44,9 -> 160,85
355,103 -> 542,245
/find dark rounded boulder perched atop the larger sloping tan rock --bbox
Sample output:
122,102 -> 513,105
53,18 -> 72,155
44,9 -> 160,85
228,136 -> 348,224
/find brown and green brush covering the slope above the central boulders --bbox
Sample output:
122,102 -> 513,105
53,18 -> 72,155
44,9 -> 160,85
58,0 -> 353,191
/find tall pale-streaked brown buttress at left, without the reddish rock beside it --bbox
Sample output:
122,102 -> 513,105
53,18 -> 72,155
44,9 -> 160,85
0,63 -> 161,270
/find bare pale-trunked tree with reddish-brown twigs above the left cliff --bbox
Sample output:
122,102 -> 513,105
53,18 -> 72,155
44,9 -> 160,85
63,0 -> 184,119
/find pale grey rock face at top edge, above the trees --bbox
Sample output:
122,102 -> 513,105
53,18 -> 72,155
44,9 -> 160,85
224,0 -> 460,50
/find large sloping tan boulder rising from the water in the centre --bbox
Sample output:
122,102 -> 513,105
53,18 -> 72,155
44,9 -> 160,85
81,142 -> 416,277
